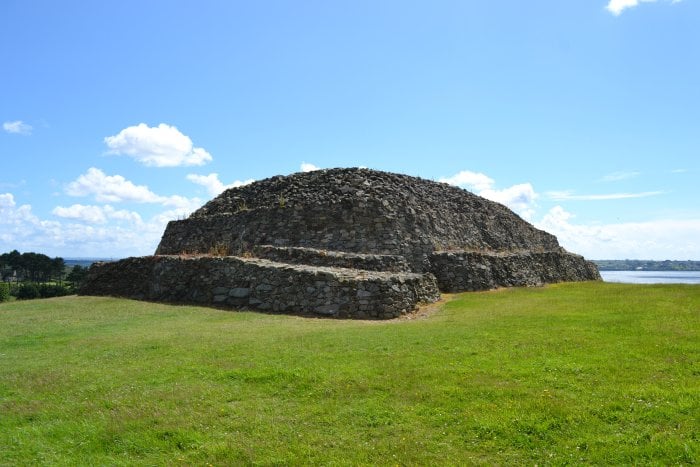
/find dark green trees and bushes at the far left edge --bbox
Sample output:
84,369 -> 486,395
0,250 -> 87,302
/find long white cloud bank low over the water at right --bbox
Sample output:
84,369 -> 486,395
536,206 -> 700,260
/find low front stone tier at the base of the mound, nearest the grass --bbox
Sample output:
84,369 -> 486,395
81,256 -> 440,319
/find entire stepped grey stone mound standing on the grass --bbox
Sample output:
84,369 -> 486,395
81,169 -> 600,318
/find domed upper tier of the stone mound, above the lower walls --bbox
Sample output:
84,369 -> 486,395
157,169 -> 559,272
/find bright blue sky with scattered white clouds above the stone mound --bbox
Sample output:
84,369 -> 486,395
0,0 -> 700,260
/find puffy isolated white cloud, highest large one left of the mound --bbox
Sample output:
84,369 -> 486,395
104,123 -> 212,167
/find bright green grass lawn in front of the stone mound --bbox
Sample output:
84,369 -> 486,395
0,283 -> 700,465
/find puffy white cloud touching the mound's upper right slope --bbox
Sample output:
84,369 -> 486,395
439,170 -> 537,219
